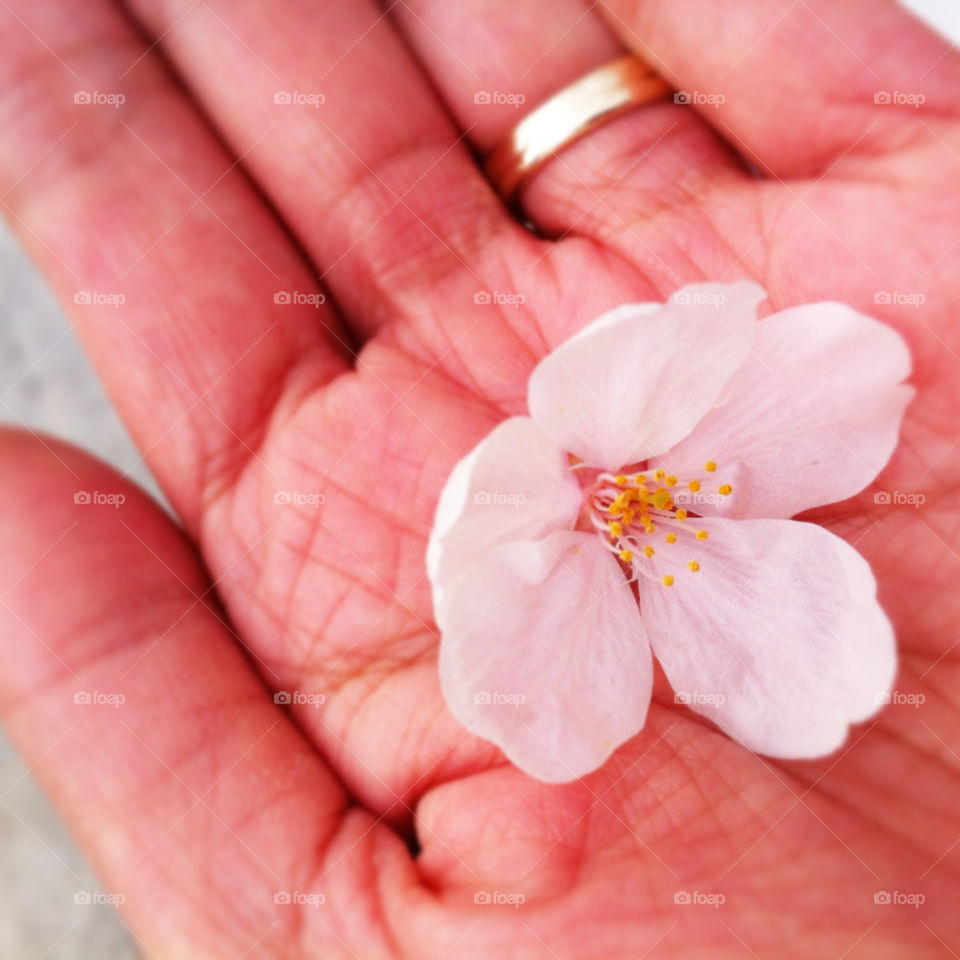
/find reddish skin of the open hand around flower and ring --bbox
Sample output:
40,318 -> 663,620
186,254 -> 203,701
0,0 -> 960,960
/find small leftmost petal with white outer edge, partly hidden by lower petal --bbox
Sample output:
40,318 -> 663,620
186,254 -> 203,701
427,417 -> 582,608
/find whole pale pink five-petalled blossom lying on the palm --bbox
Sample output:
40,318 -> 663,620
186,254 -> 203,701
427,283 -> 913,782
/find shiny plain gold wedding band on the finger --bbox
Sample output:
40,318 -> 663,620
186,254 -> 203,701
484,54 -> 670,203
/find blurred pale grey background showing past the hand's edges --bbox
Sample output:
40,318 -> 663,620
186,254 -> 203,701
0,0 -> 960,960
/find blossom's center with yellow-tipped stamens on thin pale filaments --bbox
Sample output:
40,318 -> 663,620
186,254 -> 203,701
590,460 -> 733,587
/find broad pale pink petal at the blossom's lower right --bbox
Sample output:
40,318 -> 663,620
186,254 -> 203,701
640,520 -> 896,759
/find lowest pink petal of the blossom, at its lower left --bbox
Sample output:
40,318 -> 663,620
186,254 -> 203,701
440,531 -> 653,783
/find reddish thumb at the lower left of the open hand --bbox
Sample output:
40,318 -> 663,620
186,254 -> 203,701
0,430 -> 405,958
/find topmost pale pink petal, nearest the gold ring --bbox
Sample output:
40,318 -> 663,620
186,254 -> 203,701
527,282 -> 766,470
